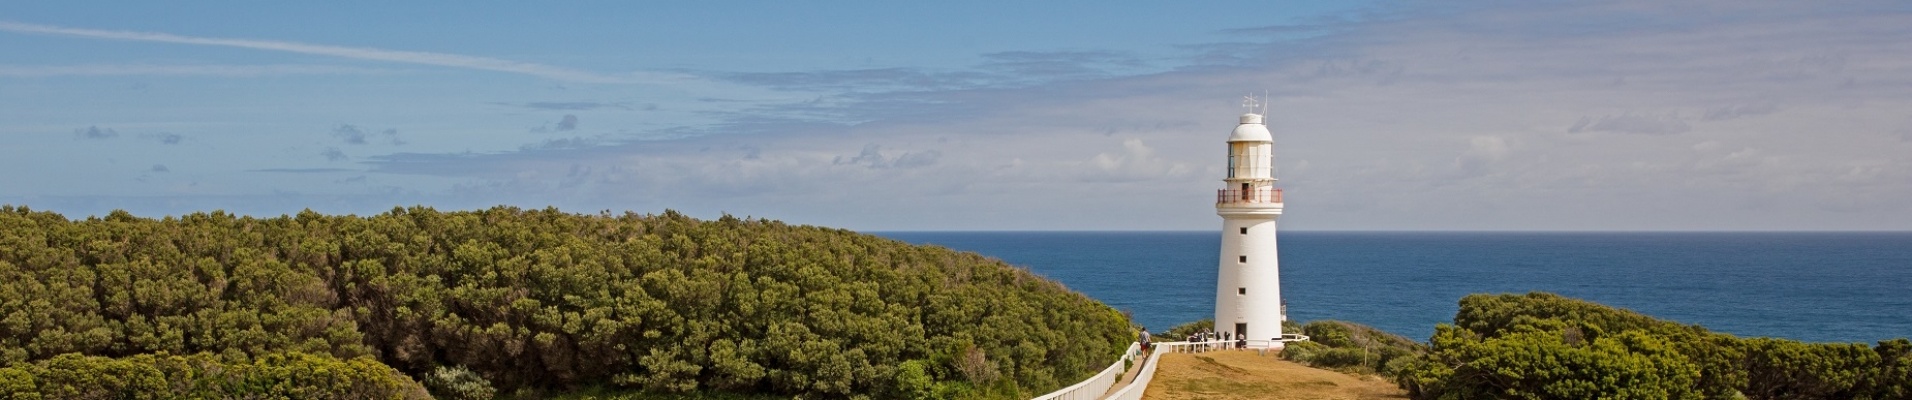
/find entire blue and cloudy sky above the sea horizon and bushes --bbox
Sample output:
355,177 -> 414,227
0,0 -> 1912,232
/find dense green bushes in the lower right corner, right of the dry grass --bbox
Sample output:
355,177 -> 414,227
1394,293 -> 1912,400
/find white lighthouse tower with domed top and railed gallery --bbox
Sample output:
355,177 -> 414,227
1214,100 -> 1287,348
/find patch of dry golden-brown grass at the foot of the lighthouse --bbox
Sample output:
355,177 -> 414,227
1141,350 -> 1407,400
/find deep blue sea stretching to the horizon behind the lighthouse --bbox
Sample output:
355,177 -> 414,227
878,232 -> 1912,343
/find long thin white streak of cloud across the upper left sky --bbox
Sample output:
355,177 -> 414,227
0,21 -> 686,84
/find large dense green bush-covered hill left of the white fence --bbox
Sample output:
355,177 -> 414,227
0,207 -> 1132,398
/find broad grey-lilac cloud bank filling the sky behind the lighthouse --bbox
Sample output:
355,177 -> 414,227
22,0 -> 1912,230
